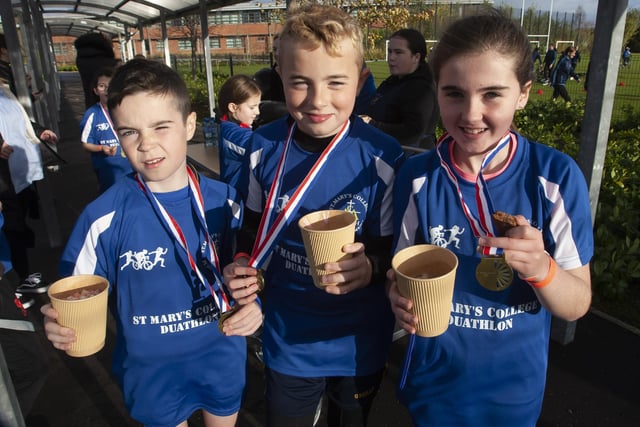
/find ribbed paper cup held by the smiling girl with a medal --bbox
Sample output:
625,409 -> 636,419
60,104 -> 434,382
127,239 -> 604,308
391,245 -> 458,337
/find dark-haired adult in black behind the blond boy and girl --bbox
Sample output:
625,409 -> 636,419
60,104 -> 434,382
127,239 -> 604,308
362,28 -> 438,148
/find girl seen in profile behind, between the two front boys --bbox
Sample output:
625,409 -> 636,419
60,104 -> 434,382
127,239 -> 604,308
218,74 -> 260,197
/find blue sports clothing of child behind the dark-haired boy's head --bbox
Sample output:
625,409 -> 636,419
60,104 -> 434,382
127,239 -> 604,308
80,102 -> 133,191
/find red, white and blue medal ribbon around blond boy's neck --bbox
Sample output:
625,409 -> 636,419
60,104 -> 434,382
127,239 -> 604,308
249,120 -> 350,268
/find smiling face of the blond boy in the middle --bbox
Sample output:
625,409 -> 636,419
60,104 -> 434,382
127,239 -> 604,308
279,39 -> 362,137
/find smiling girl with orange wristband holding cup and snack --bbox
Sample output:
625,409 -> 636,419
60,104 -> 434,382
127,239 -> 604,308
388,12 -> 593,426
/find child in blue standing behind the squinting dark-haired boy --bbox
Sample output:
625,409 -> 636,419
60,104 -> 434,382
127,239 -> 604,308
80,68 -> 133,193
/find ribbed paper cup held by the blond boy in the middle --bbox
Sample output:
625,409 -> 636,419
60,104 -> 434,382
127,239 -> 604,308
298,210 -> 356,288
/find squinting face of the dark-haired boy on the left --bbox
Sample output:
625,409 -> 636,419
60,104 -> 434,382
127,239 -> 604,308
112,92 -> 196,192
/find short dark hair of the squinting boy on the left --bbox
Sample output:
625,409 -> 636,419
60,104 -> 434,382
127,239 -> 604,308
107,59 -> 191,120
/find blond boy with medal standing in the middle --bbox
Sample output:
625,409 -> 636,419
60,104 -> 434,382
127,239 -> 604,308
225,5 -> 403,427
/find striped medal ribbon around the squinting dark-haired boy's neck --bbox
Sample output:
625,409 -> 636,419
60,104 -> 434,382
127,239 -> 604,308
135,167 -> 231,314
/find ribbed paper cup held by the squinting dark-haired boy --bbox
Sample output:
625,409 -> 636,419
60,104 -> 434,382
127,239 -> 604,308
48,274 -> 109,357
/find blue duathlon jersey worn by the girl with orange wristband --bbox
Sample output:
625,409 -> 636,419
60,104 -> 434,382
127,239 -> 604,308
394,132 -> 593,427
